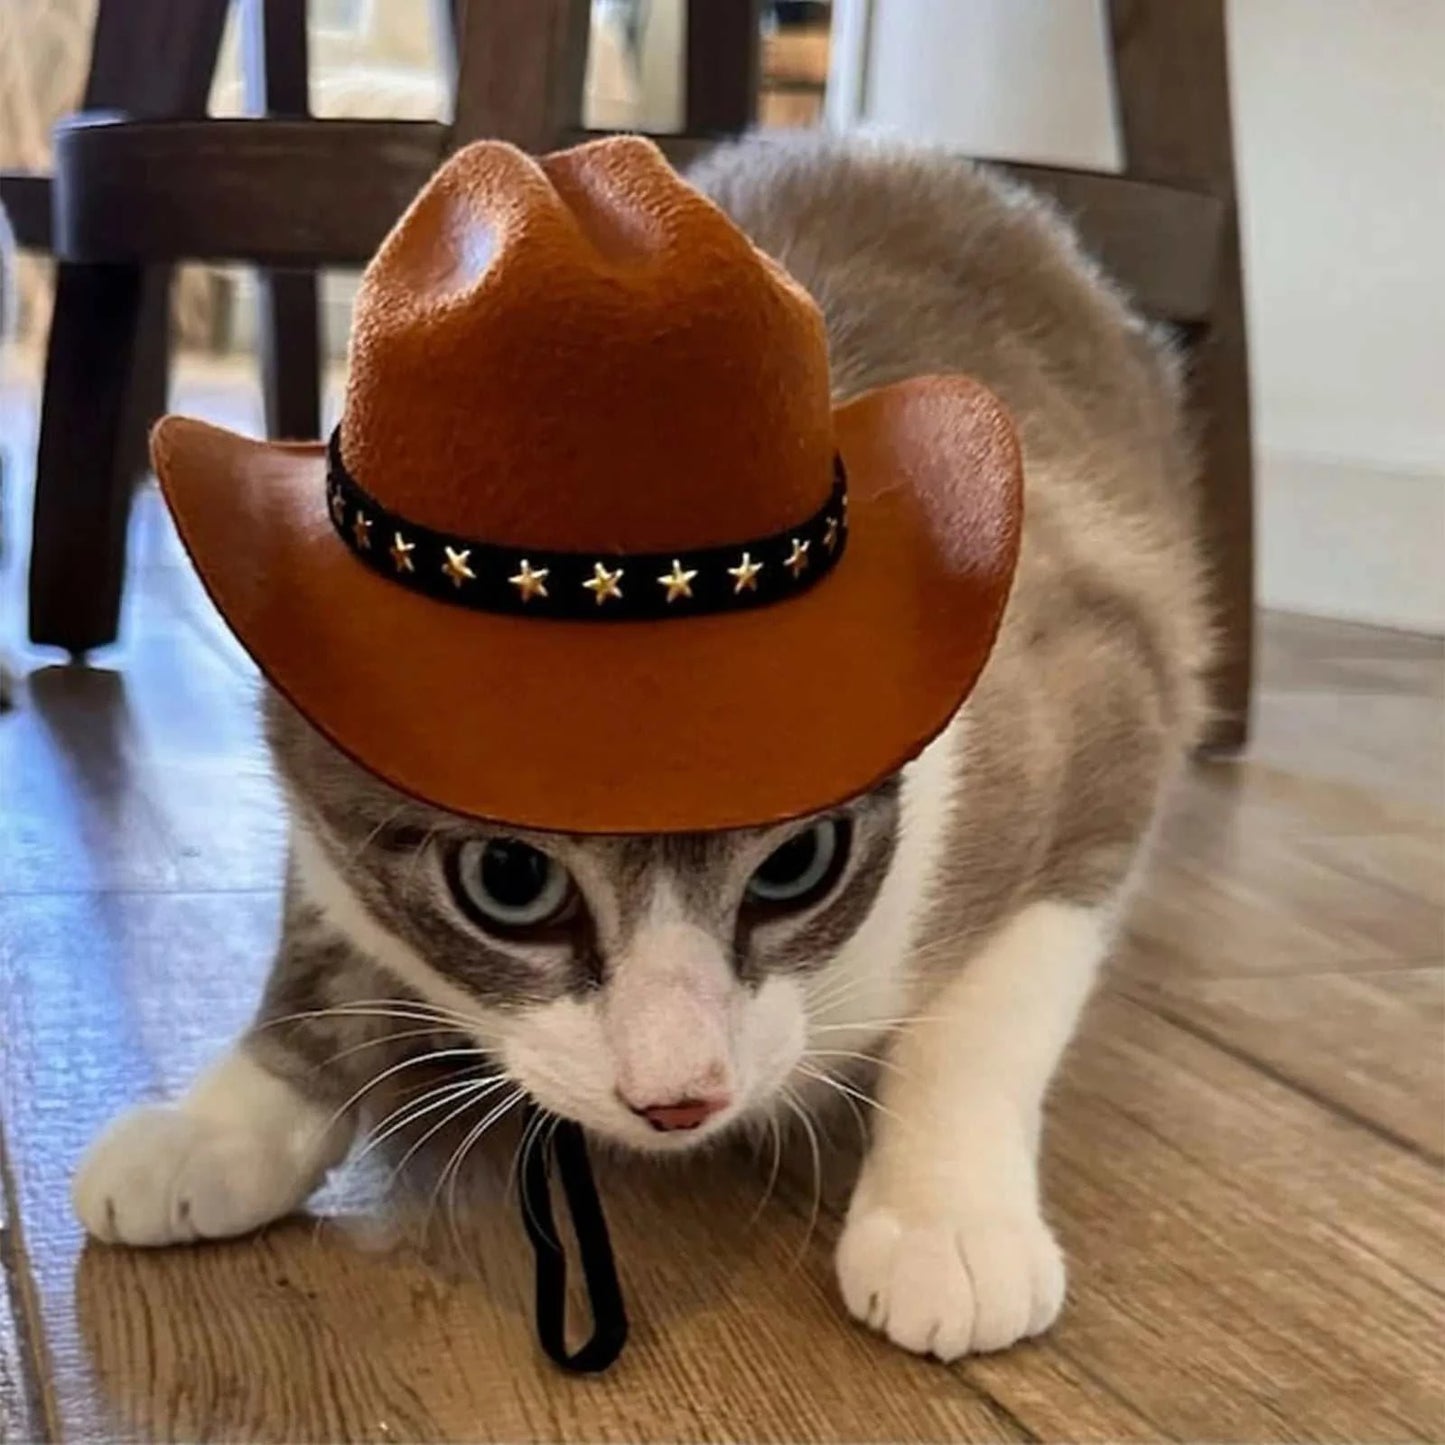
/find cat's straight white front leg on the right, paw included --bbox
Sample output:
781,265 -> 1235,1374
837,902 -> 1105,1360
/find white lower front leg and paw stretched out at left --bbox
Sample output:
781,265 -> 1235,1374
71,1042 -> 354,1244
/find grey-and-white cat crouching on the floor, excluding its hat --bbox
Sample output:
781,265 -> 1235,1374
74,134 -> 1209,1360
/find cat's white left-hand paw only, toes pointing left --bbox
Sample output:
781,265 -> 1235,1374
71,1104 -> 325,1244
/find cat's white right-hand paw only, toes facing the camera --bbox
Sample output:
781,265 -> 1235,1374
837,1207 -> 1064,1360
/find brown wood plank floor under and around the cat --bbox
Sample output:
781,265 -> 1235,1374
0,352 -> 1445,1441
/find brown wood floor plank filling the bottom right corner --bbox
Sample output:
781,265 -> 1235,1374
1040,998 -> 1445,1441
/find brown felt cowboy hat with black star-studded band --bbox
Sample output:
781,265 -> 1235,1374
152,137 -> 1020,832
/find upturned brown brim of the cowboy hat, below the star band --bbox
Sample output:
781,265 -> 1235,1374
152,377 -> 1022,834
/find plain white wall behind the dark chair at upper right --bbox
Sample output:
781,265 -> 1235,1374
834,0 -> 1445,631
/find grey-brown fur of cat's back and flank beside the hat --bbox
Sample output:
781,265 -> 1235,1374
692,133 -> 1209,939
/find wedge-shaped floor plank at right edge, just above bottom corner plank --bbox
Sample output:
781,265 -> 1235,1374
1136,965 -> 1445,1162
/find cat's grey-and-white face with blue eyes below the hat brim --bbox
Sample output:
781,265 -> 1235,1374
269,701 -> 948,1150
